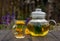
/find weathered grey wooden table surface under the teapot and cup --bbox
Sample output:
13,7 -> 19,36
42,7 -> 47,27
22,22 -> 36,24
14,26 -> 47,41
0,27 -> 60,41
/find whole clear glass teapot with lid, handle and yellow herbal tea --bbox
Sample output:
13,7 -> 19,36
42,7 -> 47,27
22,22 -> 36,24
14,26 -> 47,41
27,8 -> 56,36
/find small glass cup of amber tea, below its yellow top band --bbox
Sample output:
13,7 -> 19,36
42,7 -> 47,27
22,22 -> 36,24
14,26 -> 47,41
13,24 -> 25,38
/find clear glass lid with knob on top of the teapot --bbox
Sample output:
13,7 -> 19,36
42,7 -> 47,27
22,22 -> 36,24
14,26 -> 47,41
31,8 -> 46,18
